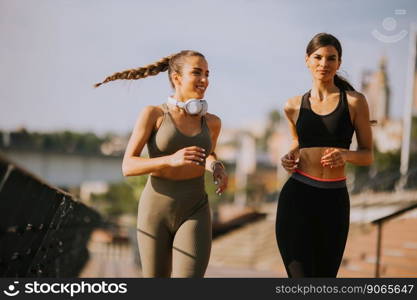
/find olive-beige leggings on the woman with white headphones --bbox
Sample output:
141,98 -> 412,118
137,176 -> 212,277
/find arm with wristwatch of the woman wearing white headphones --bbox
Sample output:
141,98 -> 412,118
206,114 -> 228,194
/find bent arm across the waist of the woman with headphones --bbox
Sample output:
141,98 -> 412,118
122,106 -> 204,176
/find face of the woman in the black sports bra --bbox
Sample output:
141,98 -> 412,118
306,46 -> 341,81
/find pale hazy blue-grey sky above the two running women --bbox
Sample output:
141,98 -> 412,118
0,0 -> 417,134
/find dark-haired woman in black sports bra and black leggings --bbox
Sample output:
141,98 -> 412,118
276,33 -> 373,277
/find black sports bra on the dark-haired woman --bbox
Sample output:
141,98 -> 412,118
296,89 -> 355,149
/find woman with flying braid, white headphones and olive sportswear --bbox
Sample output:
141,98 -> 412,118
95,50 -> 228,277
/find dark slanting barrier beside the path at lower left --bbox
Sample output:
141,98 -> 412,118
0,156 -> 101,277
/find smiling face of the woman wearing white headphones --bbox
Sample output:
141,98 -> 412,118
173,56 -> 209,101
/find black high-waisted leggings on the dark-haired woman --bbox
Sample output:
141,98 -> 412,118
276,178 -> 349,277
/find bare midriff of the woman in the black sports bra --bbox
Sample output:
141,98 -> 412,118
297,147 -> 346,179
